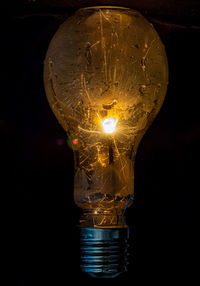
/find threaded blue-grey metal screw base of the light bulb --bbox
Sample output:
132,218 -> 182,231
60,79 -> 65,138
80,227 -> 129,278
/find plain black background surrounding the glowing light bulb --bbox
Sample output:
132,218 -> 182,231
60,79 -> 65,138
0,1 -> 200,286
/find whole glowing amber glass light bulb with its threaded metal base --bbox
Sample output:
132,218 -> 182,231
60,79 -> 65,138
44,7 -> 168,277
